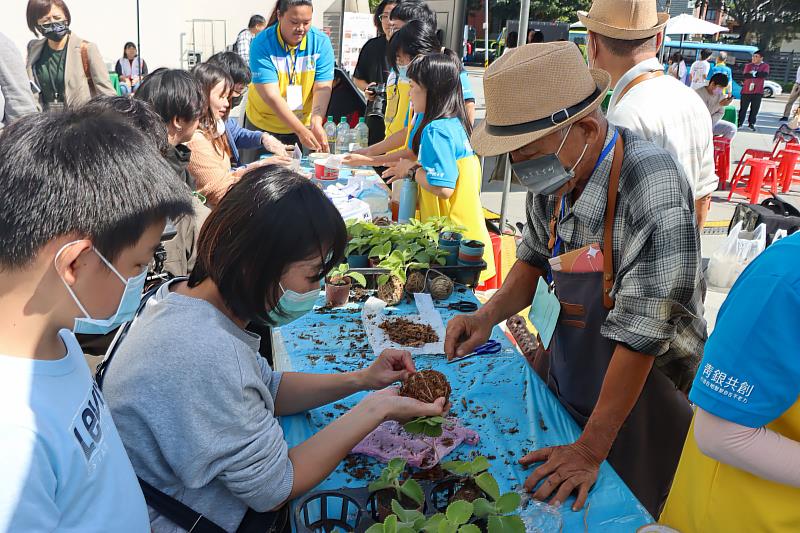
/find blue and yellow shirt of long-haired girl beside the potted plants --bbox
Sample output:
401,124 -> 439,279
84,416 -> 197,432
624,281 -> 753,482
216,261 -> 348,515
408,114 -> 495,281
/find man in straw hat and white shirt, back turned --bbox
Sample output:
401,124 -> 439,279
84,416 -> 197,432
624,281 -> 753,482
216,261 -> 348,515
578,0 -> 719,233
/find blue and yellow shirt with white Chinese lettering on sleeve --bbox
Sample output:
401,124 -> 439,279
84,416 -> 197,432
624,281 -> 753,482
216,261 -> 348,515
660,235 -> 800,533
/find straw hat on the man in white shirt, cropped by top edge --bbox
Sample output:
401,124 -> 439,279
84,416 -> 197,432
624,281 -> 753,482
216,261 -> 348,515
578,0 -> 669,41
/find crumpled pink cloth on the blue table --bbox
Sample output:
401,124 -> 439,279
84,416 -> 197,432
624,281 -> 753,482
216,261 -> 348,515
353,418 -> 480,468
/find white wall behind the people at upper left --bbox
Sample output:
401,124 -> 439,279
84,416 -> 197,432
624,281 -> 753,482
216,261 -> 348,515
0,0 -> 341,70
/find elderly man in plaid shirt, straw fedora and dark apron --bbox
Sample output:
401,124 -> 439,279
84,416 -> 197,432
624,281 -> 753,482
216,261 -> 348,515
445,42 -> 706,516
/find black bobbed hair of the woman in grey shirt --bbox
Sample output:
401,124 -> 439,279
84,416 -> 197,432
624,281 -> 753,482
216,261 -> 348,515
189,165 -> 347,325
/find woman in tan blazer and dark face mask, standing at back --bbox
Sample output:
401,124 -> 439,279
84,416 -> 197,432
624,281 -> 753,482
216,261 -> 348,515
26,0 -> 117,111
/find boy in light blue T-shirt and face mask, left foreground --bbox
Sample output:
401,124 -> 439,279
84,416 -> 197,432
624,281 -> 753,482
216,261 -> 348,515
0,110 -> 191,533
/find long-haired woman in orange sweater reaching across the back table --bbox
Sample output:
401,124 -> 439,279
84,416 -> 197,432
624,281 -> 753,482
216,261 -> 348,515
187,63 -> 291,208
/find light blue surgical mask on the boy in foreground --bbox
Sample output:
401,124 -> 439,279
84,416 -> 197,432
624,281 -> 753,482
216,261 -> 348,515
56,241 -> 147,335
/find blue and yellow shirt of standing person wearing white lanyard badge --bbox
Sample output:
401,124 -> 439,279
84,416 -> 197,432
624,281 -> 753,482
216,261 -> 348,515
246,24 -> 334,133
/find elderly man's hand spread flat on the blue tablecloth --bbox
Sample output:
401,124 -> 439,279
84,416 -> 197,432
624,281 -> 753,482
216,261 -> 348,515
519,442 -> 603,511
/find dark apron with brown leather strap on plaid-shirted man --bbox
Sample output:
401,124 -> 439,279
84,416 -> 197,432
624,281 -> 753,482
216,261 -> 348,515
536,136 -> 692,517
